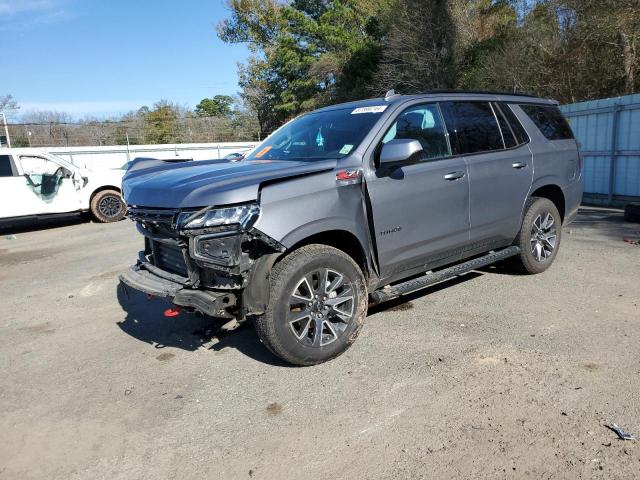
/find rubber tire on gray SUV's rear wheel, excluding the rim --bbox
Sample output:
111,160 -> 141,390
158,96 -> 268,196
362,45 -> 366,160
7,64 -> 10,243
507,197 -> 562,274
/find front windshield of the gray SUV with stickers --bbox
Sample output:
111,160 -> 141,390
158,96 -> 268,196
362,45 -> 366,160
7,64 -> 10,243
247,105 -> 387,160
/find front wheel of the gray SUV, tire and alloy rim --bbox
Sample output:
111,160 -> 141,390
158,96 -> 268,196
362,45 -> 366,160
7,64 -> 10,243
255,245 -> 367,366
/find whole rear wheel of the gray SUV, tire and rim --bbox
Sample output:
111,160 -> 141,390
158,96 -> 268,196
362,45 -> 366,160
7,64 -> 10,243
509,197 -> 562,274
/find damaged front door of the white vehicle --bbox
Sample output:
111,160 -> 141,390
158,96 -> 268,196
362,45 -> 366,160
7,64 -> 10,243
19,155 -> 81,214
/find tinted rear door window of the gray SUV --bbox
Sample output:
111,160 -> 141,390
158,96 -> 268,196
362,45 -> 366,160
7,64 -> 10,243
441,102 -> 504,155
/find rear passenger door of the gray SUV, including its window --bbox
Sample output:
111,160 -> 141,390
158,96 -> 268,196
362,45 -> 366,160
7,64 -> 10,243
441,101 -> 533,250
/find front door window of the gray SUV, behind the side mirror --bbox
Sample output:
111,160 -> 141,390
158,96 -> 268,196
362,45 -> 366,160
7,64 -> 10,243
382,104 -> 449,160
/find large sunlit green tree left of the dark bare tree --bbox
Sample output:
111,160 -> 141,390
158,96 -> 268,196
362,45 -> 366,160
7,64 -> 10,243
218,0 -> 394,133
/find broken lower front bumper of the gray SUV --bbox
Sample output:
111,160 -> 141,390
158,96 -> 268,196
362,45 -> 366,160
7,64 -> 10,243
120,260 -> 236,318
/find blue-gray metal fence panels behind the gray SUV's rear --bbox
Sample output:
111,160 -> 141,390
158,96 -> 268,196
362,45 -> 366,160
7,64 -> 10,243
561,94 -> 640,206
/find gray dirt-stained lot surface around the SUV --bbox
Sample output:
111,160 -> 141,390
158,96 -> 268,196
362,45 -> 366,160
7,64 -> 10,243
0,209 -> 640,479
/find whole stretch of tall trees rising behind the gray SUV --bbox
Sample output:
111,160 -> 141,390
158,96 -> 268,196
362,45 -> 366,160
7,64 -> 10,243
218,0 -> 640,131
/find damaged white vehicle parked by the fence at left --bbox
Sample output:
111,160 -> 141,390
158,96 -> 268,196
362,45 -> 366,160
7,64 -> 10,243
0,149 -> 126,223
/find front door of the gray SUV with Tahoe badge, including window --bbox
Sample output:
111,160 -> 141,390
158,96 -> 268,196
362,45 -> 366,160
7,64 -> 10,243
367,103 -> 469,278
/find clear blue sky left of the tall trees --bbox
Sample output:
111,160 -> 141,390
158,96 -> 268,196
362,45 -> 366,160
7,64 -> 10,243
0,0 -> 248,118
